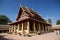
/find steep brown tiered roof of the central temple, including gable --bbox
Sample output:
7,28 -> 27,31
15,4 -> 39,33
9,6 -> 50,25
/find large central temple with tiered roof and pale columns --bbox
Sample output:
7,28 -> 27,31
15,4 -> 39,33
9,6 -> 51,34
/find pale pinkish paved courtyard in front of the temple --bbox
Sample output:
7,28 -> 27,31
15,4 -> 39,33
0,32 -> 60,40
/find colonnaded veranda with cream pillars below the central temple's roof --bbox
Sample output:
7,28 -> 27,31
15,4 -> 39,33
9,18 -> 51,34
